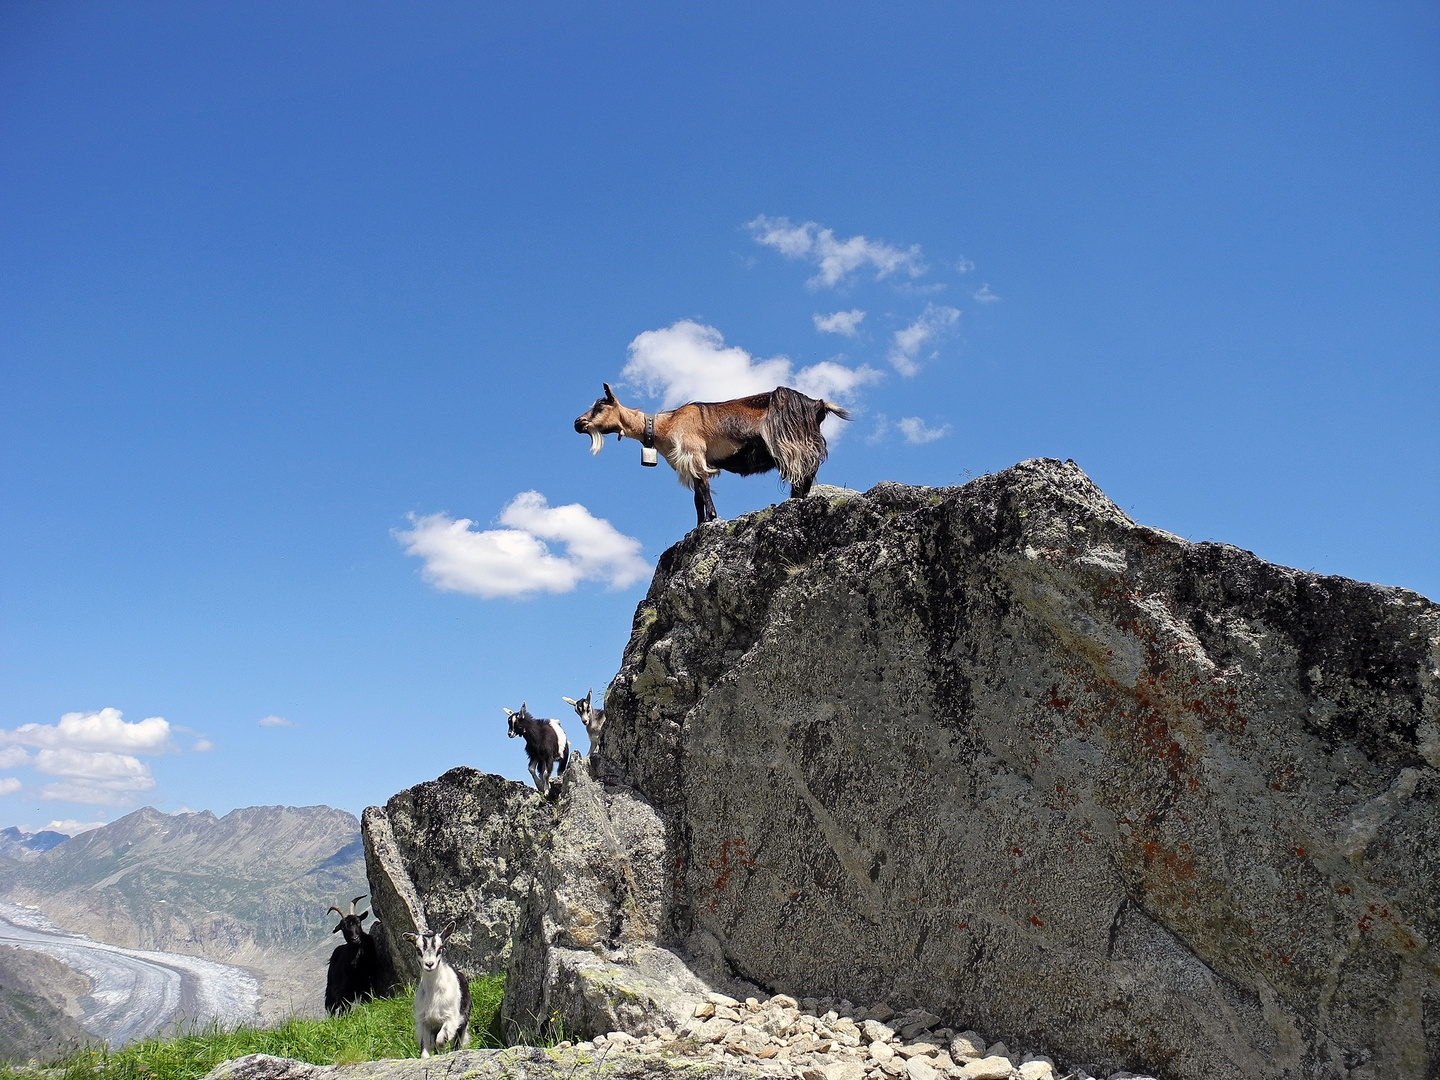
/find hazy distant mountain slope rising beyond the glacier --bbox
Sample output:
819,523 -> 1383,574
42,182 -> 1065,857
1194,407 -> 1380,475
0,806 -> 369,1020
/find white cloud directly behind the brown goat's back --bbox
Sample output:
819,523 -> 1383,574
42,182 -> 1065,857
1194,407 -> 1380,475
621,318 -> 883,409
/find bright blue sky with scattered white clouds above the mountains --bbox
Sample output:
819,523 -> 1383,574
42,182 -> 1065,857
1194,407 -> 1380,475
0,0 -> 1440,828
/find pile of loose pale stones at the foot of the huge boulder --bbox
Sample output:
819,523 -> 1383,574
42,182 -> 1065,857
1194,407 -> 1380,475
557,994 -> 1151,1080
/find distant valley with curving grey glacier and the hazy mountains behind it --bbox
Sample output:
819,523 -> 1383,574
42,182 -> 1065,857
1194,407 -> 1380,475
0,806 -> 369,1060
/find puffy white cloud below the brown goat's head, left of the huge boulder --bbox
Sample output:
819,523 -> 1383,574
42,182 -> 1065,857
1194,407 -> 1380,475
395,491 -> 651,599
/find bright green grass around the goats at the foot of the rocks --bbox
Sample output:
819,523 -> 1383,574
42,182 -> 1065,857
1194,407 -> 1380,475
0,976 -> 505,1080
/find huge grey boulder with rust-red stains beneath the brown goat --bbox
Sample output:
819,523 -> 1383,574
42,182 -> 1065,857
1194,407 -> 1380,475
590,461 -> 1440,1080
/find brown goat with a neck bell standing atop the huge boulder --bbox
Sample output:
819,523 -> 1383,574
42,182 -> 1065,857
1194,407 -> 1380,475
575,383 -> 850,526
